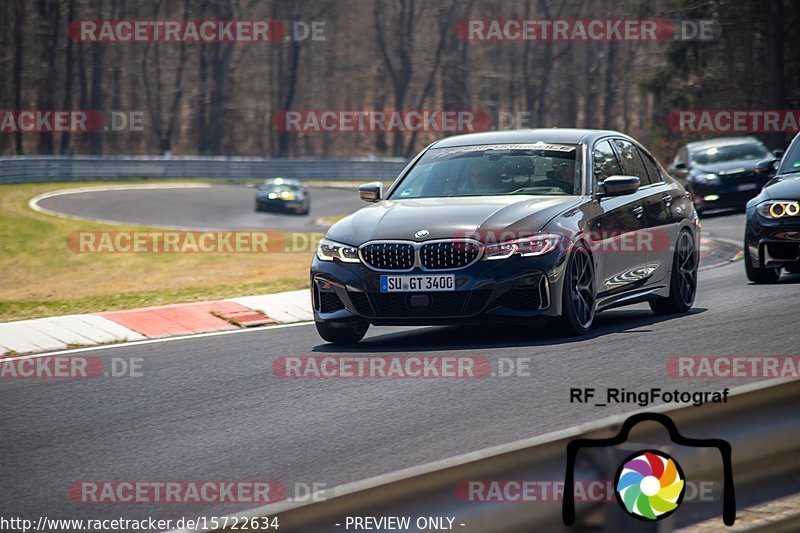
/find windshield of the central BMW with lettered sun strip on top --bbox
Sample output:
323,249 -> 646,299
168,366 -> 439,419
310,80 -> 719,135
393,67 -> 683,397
390,142 -> 581,200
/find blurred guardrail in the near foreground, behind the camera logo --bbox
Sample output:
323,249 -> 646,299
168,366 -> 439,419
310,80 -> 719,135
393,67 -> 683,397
180,380 -> 800,532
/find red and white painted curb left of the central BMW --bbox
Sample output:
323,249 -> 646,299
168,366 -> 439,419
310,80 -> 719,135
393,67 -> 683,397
0,289 -> 314,355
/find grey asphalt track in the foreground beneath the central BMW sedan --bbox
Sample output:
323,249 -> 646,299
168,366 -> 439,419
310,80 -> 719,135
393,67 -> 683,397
0,211 -> 800,528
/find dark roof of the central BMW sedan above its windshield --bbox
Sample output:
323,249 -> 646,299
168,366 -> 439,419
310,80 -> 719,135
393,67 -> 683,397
434,128 -> 628,148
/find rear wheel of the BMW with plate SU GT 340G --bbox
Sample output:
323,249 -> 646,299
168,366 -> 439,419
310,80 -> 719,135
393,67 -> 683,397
650,230 -> 698,315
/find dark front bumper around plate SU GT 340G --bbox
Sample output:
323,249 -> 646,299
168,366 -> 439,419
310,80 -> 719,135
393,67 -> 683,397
311,251 -> 566,325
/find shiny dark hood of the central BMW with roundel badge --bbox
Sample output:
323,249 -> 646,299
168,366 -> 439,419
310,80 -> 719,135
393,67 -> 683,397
328,196 -> 581,246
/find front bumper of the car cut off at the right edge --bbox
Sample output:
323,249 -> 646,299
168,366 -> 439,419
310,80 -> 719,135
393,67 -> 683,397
745,208 -> 800,268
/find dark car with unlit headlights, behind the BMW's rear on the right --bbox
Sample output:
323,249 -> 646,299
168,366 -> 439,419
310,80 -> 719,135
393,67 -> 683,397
669,137 -> 772,213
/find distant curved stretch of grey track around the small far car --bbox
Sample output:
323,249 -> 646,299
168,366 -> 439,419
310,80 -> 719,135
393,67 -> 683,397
39,186 -> 364,231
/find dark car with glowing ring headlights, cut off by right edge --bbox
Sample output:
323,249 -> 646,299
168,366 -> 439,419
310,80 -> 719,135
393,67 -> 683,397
744,134 -> 800,283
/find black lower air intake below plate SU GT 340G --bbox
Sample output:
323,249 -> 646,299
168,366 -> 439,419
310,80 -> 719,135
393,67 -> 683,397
358,290 -> 491,318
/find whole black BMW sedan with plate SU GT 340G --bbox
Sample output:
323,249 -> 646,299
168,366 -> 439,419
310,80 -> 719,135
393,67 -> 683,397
311,129 -> 700,343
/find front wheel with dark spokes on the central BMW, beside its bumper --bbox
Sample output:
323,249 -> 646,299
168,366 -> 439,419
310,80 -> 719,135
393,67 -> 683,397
560,243 -> 597,335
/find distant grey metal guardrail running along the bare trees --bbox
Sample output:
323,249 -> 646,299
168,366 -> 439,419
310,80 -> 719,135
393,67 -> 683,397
0,156 -> 408,184
